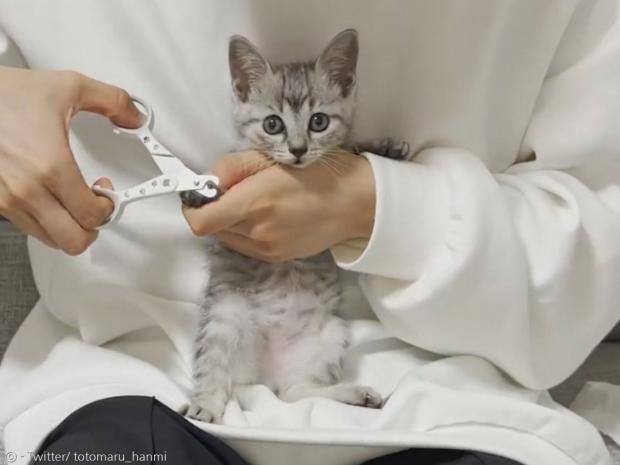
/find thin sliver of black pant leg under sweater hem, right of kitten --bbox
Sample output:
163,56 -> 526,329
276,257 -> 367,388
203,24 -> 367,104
363,449 -> 522,465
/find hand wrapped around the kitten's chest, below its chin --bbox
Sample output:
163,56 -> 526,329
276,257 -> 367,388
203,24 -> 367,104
183,152 -> 375,262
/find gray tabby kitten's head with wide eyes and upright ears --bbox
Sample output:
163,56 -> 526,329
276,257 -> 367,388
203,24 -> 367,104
229,29 -> 358,168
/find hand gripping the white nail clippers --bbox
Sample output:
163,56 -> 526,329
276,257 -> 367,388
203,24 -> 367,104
0,67 -> 142,255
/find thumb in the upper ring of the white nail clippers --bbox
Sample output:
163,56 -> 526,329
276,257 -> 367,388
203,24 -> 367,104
79,76 -> 144,128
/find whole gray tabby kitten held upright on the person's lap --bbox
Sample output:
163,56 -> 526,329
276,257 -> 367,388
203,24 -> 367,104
182,30 -> 409,422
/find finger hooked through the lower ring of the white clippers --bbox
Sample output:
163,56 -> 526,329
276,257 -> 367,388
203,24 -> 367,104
44,147 -> 114,230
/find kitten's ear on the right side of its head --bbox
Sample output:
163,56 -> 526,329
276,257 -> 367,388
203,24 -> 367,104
315,29 -> 359,97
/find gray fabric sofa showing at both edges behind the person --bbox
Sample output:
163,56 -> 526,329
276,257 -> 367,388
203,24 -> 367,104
0,218 -> 620,465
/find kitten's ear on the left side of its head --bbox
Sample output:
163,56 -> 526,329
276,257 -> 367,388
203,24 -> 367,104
228,36 -> 270,102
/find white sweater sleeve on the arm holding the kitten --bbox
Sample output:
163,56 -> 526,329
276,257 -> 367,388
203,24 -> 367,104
332,4 -> 620,389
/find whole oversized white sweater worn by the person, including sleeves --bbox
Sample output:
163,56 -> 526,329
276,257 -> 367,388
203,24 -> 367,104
0,0 -> 620,465
